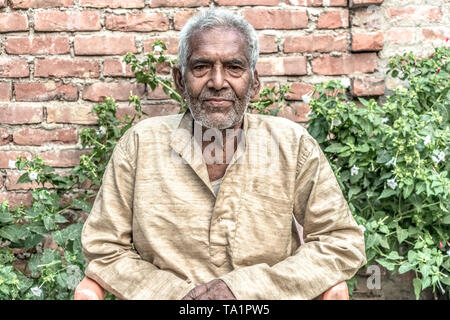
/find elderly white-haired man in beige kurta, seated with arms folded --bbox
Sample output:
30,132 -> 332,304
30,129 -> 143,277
82,9 -> 365,299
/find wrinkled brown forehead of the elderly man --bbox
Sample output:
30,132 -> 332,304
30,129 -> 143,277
189,28 -> 248,62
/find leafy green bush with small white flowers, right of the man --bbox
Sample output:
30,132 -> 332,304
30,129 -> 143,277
308,47 -> 450,299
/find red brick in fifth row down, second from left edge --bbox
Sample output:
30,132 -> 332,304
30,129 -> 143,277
14,81 -> 78,101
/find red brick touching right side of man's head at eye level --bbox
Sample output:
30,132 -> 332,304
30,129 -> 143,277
256,57 -> 307,76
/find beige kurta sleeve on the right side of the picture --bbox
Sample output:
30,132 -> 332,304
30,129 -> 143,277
221,134 -> 366,299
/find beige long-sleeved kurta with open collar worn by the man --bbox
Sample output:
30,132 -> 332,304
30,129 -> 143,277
82,111 -> 366,299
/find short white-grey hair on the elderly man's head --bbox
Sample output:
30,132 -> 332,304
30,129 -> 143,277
178,8 -> 259,75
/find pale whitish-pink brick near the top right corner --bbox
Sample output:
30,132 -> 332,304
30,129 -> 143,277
386,6 -> 442,24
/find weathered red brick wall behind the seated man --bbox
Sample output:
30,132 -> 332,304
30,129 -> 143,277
0,0 -> 450,298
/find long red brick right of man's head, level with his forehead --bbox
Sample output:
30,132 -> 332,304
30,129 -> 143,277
284,33 -> 348,53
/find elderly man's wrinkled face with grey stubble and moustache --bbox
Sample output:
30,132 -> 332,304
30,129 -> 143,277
176,28 -> 259,129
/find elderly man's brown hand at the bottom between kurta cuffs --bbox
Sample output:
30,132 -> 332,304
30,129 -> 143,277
182,279 -> 236,300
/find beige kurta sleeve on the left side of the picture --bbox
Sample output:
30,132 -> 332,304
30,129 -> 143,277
82,129 -> 193,299
